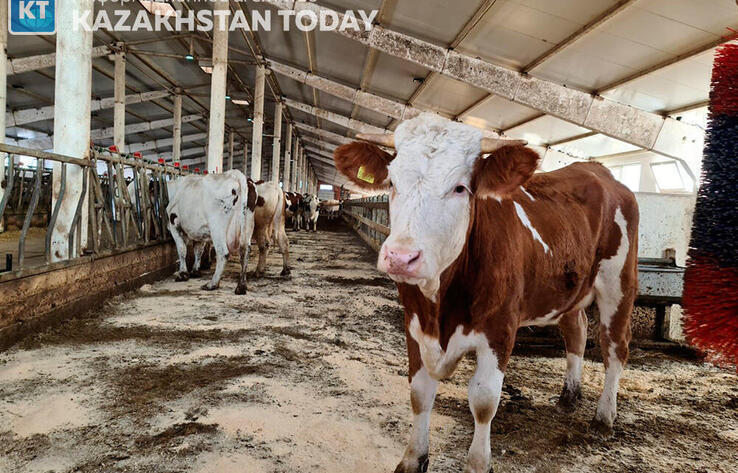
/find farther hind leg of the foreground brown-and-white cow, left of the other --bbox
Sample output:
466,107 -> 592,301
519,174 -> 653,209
557,309 -> 587,412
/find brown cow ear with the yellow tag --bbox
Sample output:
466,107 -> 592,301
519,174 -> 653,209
333,141 -> 393,190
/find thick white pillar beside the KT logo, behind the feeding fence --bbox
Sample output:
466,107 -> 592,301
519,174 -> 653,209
51,0 -> 93,261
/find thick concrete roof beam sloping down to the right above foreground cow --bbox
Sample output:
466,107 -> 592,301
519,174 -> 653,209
265,0 -> 704,160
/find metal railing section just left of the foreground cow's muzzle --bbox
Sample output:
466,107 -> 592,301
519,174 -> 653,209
341,194 -> 390,251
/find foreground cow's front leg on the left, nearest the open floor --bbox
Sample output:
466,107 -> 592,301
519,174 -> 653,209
395,335 -> 438,473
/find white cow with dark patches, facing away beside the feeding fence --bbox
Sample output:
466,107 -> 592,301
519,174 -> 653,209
167,170 -> 263,294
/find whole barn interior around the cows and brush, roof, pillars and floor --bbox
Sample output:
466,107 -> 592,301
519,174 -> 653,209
0,0 -> 738,473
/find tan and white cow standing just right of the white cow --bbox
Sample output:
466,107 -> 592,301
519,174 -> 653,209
254,181 -> 290,277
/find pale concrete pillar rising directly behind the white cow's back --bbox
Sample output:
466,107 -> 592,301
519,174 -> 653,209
207,0 -> 230,173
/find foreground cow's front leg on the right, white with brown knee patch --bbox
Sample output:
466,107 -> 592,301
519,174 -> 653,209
464,338 -> 506,473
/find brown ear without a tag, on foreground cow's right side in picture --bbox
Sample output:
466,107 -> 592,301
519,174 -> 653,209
472,145 -> 539,200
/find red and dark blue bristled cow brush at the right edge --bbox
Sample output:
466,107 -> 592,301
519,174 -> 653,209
683,44 -> 738,364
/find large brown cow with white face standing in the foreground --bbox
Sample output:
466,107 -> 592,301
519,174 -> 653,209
335,114 -> 638,473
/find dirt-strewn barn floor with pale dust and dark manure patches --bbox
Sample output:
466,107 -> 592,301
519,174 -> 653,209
0,221 -> 738,473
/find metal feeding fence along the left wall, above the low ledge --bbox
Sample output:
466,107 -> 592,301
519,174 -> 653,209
0,144 -> 189,281
